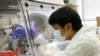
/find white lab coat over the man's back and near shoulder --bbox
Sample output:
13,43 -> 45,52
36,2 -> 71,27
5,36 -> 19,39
38,25 -> 100,56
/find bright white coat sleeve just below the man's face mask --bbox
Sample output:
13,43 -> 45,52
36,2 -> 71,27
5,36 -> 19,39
38,41 -> 70,56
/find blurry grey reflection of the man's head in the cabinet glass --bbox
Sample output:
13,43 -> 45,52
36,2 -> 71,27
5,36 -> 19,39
29,11 -> 47,33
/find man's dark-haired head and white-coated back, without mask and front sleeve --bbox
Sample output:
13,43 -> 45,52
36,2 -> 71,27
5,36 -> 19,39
47,7 -> 100,56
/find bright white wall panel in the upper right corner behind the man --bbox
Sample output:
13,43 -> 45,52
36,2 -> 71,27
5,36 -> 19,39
83,0 -> 100,20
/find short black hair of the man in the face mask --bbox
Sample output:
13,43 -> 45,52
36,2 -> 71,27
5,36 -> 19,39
49,7 -> 82,31
